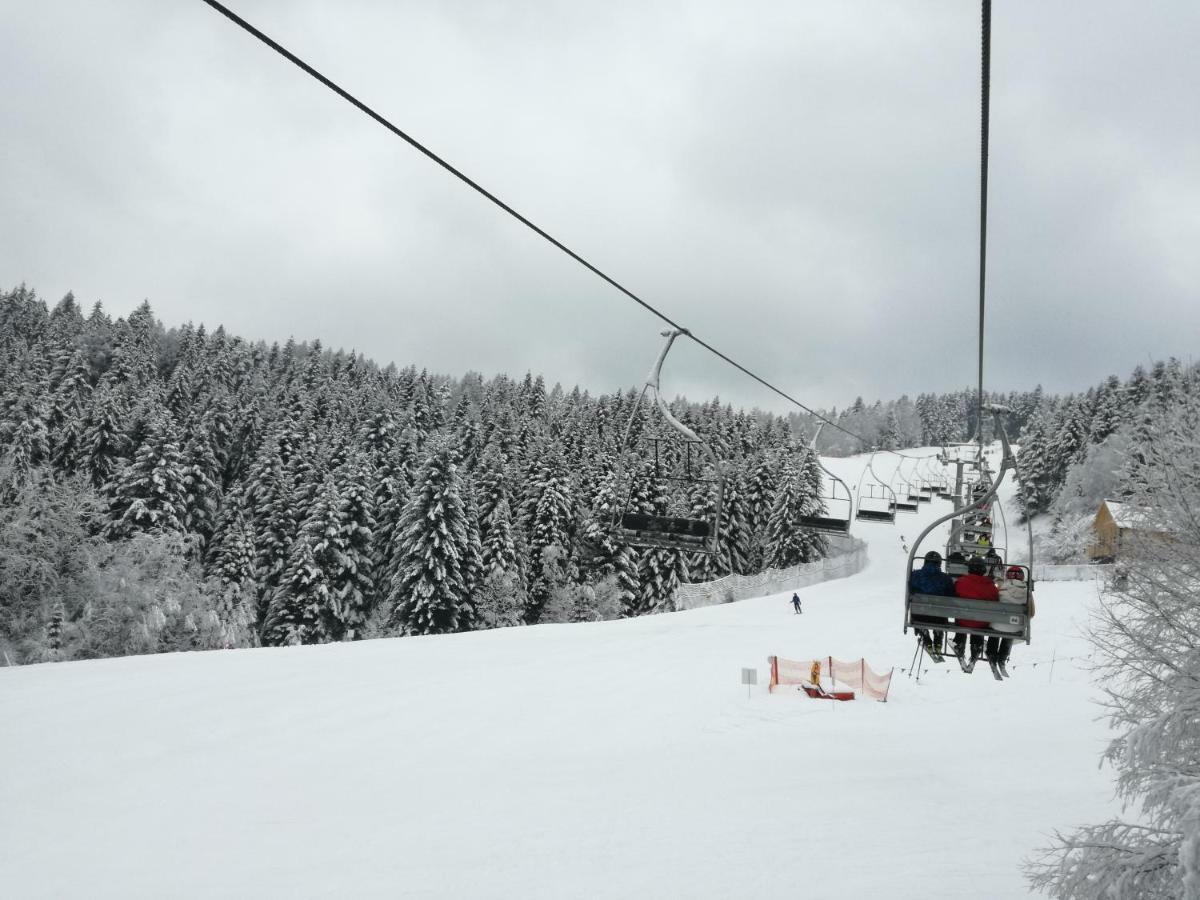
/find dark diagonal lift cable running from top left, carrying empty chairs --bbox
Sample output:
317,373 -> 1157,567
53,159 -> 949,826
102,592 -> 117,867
203,0 -> 936,458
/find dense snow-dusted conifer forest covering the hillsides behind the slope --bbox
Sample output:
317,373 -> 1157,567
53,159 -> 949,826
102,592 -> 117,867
0,286 -> 1200,664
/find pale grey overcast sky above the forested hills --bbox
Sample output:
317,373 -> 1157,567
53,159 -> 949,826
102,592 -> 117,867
0,0 -> 1200,409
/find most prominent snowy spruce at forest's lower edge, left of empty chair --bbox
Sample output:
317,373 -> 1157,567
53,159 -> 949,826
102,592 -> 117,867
386,444 -> 472,635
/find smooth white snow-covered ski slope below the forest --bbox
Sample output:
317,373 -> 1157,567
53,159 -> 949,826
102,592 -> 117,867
0,451 -> 1112,900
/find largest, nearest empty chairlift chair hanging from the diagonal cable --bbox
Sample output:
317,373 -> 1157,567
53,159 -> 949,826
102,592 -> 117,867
611,329 -> 725,553
